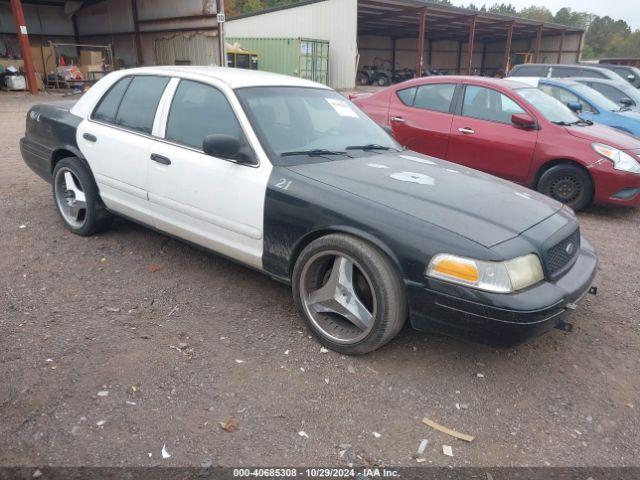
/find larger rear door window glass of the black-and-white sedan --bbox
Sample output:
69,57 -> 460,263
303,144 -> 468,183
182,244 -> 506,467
116,76 -> 169,133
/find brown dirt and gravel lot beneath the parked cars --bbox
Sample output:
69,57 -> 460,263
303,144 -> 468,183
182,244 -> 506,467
0,93 -> 640,466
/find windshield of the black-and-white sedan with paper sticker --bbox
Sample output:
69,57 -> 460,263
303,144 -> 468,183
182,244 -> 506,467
236,87 -> 401,165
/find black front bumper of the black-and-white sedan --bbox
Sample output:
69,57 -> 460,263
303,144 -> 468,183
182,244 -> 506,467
408,238 -> 598,348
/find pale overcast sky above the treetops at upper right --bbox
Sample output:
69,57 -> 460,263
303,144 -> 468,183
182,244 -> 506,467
451,0 -> 640,29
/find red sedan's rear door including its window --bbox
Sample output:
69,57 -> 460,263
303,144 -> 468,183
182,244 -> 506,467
389,83 -> 456,158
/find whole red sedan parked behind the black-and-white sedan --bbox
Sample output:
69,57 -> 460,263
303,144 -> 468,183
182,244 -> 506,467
352,76 -> 640,210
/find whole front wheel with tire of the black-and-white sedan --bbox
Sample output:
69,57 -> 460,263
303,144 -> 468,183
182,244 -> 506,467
292,234 -> 407,355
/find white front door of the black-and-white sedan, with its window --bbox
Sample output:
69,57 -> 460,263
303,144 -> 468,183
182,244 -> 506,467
148,79 -> 272,268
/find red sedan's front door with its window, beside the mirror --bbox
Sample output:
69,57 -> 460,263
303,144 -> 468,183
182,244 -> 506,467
446,85 -> 538,184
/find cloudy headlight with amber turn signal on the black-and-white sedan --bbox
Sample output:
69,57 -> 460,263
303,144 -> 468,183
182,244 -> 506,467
425,253 -> 544,293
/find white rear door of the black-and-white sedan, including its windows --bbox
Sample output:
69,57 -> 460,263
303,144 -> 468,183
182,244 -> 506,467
76,75 -> 169,222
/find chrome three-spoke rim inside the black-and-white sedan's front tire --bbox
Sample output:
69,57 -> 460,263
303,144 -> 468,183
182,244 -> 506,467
300,251 -> 377,345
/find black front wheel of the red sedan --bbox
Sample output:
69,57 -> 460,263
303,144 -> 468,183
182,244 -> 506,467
538,164 -> 593,211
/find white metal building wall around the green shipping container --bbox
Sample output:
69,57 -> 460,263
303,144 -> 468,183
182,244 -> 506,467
225,0 -> 358,89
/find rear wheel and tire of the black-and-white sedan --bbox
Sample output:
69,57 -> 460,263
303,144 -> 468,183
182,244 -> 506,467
53,157 -> 112,236
